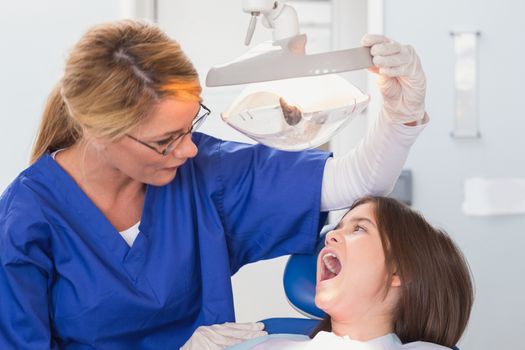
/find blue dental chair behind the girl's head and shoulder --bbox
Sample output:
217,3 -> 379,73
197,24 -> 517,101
260,225 -> 459,350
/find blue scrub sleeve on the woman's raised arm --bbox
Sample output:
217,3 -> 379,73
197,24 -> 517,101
200,134 -> 330,274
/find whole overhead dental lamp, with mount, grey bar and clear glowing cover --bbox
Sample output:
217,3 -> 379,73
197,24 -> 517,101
206,0 -> 373,151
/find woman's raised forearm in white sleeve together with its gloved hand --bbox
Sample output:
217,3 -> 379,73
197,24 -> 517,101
321,35 -> 428,211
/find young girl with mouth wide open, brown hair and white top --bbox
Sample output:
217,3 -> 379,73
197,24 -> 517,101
227,197 -> 473,350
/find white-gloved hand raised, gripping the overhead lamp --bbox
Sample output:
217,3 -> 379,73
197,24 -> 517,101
361,34 -> 426,124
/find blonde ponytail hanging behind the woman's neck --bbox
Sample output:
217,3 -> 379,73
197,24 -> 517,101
30,83 -> 82,164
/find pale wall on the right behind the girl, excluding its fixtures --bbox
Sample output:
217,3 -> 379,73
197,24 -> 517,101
384,0 -> 525,350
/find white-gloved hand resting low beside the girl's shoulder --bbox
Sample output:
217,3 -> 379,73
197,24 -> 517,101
181,322 -> 268,350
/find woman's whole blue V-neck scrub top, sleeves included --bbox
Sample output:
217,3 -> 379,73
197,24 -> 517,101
0,133 -> 329,349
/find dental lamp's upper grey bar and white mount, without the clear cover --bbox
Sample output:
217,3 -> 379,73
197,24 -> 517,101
206,0 -> 373,87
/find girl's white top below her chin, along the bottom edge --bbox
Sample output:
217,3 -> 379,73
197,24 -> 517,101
252,332 -> 450,350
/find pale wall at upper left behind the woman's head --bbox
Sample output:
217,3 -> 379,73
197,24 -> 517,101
0,0 -> 127,192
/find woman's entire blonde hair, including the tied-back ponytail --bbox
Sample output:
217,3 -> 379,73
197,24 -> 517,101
31,20 -> 201,163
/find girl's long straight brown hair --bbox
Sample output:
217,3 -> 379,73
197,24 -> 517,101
311,197 -> 474,347
